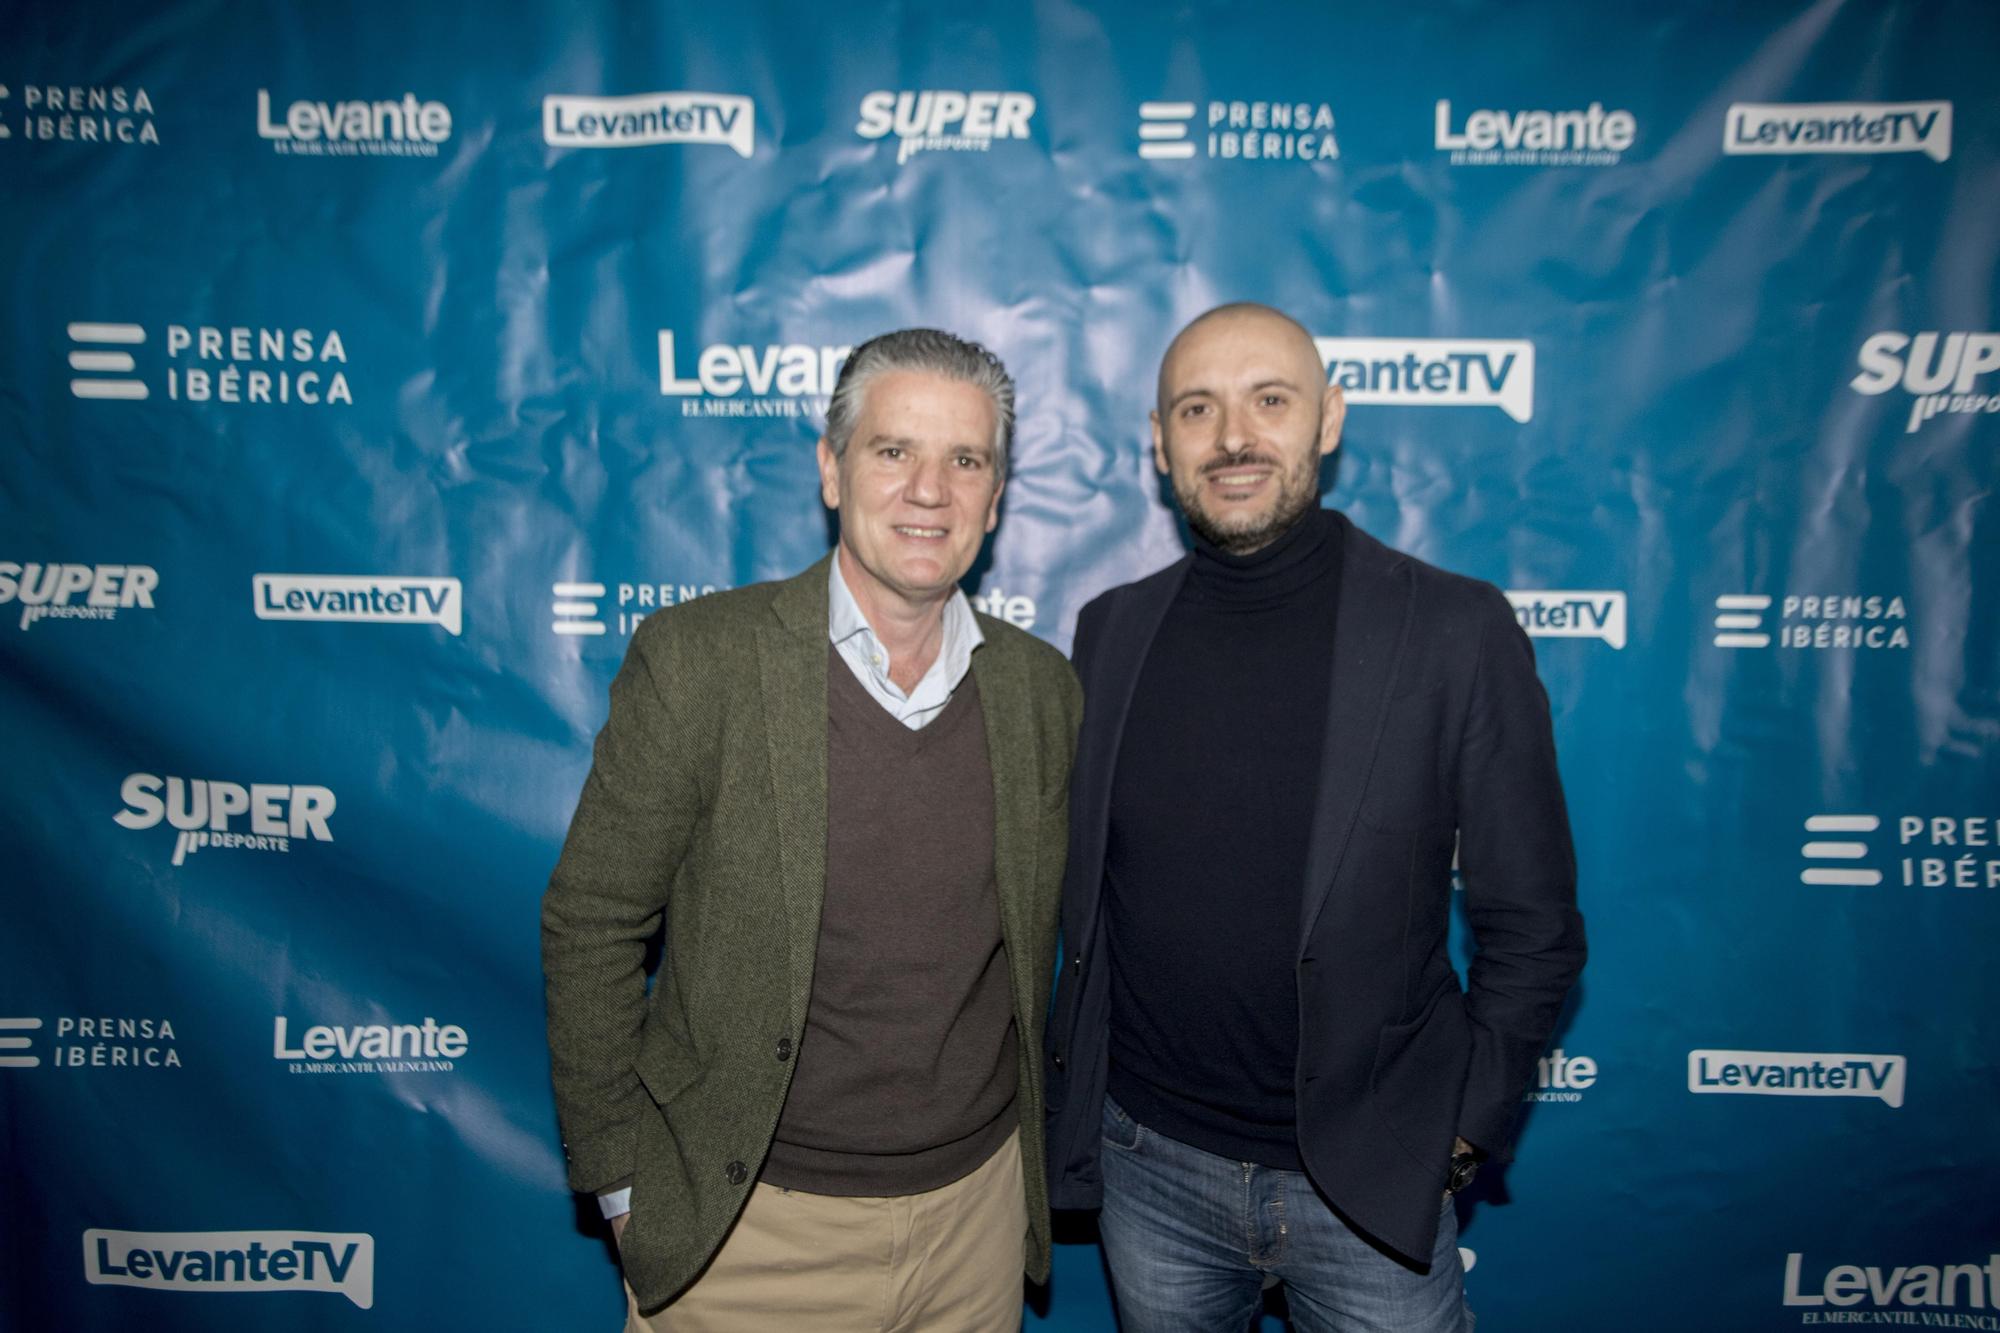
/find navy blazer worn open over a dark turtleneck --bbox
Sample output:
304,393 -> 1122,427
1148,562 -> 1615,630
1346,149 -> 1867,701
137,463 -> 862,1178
1046,516 -> 1584,1263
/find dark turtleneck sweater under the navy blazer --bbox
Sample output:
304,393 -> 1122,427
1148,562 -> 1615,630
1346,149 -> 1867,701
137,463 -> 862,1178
1104,510 -> 1342,1171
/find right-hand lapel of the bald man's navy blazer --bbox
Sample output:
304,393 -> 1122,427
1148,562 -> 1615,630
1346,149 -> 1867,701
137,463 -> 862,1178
1298,518 -> 1416,953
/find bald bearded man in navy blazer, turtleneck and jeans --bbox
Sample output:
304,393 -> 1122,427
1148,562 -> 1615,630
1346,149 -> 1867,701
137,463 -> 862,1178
1048,304 -> 1584,1333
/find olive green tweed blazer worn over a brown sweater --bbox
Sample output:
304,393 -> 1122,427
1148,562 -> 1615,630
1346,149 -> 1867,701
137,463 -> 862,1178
542,556 -> 1082,1309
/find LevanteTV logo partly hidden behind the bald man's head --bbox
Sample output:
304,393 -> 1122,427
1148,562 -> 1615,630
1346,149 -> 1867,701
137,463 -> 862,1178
1312,338 -> 1534,422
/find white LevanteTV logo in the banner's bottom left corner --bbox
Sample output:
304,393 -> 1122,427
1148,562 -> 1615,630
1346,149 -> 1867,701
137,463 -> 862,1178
84,1227 -> 374,1309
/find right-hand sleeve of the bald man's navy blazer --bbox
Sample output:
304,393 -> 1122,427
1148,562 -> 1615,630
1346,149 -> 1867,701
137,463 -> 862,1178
1456,588 -> 1584,1159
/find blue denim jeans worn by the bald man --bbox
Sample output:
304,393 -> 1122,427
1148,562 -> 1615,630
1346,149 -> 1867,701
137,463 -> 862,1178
1098,1097 -> 1472,1333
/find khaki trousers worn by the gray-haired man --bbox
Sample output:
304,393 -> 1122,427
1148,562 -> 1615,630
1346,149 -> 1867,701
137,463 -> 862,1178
626,1131 -> 1028,1333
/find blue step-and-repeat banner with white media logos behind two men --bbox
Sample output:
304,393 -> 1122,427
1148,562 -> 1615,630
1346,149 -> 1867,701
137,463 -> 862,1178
0,0 -> 2000,1331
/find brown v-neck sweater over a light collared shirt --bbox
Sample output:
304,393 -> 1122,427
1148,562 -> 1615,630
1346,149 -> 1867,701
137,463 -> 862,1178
762,648 -> 1018,1195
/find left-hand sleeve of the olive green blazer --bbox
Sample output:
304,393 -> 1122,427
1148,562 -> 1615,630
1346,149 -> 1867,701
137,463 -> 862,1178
542,616 -> 702,1193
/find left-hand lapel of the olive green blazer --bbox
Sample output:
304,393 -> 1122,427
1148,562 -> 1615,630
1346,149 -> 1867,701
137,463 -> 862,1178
756,556 -> 830,1015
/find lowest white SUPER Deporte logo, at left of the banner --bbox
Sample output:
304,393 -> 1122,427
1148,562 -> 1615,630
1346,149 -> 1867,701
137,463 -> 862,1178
112,773 -> 336,865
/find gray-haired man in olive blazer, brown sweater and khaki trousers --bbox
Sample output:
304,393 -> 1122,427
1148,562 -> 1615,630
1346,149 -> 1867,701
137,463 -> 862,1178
542,328 -> 1082,1333
